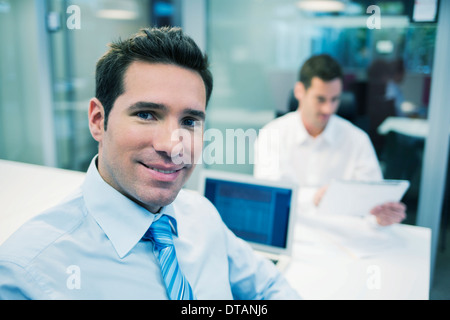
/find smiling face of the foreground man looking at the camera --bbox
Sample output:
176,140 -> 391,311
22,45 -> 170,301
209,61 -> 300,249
89,62 -> 206,213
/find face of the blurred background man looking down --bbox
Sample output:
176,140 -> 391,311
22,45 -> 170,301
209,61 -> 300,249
295,77 -> 342,136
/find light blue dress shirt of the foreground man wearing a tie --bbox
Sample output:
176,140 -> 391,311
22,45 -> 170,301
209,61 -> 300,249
0,156 -> 299,300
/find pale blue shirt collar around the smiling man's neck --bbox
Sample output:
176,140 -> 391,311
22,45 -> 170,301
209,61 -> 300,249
82,156 -> 177,258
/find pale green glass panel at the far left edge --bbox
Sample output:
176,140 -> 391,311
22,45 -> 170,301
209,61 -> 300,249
0,0 -> 46,164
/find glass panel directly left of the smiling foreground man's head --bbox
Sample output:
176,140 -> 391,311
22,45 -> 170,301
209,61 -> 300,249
47,0 -> 151,171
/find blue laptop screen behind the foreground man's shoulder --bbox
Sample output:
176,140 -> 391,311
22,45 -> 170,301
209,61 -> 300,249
204,178 -> 292,248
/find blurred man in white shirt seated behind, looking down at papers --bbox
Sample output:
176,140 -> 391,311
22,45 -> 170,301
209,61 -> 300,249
254,55 -> 406,226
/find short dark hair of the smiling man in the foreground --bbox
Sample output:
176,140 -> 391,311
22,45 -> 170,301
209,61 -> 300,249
95,27 -> 213,130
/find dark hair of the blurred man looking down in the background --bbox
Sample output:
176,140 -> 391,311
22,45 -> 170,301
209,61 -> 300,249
299,54 -> 343,89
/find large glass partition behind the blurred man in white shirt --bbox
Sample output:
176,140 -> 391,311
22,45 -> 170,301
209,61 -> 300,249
205,0 -> 436,223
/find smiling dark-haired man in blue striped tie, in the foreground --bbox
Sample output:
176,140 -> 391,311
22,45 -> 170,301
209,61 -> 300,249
0,28 -> 298,299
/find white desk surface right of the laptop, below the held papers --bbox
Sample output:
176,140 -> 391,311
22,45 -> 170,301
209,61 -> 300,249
285,210 -> 431,300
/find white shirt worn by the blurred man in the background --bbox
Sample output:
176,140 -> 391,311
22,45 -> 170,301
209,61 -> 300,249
254,111 -> 382,188
